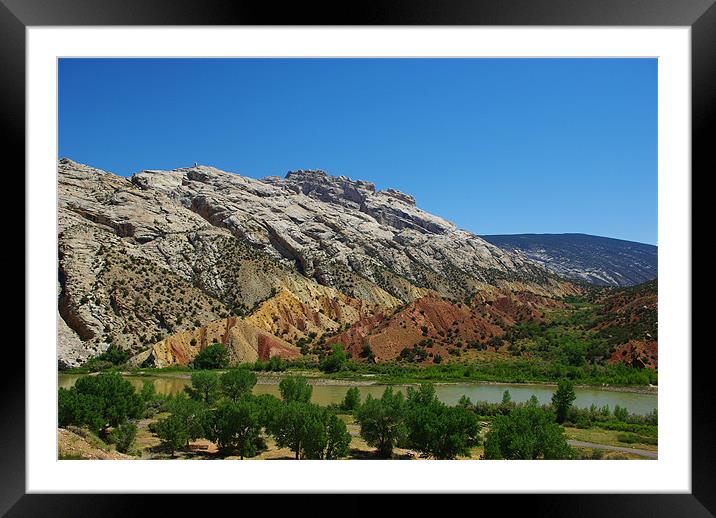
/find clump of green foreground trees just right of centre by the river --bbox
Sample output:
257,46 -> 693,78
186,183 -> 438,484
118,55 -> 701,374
352,383 -> 480,459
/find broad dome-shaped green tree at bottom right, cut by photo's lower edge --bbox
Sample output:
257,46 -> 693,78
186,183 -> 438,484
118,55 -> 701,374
484,405 -> 573,459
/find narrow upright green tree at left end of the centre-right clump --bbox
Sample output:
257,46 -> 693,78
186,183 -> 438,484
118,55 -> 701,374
356,387 -> 405,459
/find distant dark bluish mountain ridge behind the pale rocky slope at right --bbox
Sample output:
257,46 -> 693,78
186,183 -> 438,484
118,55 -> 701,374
480,234 -> 658,287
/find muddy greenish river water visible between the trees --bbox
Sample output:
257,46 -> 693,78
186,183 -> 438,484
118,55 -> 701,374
59,374 -> 657,414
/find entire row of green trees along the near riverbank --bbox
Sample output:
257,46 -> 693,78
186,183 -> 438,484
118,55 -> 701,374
58,368 -> 644,459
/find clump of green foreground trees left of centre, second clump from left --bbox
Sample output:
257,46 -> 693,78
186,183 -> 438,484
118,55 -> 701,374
153,369 -> 350,459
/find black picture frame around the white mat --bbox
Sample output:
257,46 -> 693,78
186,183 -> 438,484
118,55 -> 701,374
0,0 -> 716,517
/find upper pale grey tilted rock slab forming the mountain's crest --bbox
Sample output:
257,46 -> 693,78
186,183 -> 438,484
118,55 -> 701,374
132,167 -> 559,301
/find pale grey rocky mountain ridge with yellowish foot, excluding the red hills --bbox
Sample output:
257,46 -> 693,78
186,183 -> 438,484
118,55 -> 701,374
58,159 -> 577,366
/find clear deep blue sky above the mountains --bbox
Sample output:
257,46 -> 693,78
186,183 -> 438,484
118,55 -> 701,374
59,59 -> 657,244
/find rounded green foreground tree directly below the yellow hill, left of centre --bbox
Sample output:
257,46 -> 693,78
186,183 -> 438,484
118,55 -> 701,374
208,396 -> 265,459
